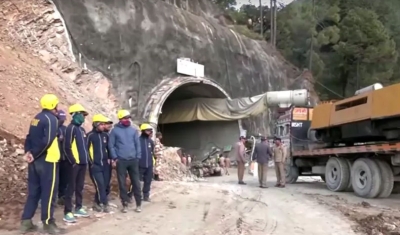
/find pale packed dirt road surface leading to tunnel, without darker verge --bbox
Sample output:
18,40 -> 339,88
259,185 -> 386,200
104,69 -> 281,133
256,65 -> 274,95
79,172 -> 355,235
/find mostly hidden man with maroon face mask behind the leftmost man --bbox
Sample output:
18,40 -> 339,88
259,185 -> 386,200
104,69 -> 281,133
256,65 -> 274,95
57,110 -> 69,205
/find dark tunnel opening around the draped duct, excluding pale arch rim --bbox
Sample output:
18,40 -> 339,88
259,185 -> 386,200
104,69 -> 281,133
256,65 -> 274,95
158,82 -> 240,157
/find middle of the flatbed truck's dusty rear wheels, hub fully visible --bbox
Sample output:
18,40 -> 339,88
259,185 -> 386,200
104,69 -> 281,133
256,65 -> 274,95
351,158 -> 382,198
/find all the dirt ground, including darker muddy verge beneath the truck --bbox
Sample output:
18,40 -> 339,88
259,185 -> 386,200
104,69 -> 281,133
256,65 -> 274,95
4,169 -> 400,235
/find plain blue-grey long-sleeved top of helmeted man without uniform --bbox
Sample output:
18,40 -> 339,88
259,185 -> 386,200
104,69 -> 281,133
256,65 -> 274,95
108,123 -> 142,160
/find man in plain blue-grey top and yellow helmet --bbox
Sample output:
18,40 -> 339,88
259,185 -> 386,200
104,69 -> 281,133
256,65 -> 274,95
108,110 -> 142,213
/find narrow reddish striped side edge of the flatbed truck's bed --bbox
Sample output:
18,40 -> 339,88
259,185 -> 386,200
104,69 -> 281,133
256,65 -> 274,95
292,142 -> 400,157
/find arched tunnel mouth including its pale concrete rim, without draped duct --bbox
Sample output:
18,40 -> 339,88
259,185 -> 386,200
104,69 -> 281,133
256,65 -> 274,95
143,77 -> 241,157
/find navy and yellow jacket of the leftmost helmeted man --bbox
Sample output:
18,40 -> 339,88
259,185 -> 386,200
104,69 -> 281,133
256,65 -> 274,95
25,110 -> 60,162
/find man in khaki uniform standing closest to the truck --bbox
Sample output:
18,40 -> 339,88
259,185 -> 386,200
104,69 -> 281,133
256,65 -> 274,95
273,138 -> 286,188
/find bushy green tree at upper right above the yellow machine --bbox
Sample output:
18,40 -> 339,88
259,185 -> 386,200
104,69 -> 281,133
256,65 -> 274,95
334,7 -> 398,95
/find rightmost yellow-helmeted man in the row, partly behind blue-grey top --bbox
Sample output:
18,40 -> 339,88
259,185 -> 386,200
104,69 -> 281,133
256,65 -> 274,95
139,123 -> 154,202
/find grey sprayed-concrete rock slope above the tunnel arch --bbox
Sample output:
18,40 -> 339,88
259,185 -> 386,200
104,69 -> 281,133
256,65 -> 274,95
54,0 -> 308,133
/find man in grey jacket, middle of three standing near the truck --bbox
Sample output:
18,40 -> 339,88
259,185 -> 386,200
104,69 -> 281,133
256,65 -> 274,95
252,137 -> 272,188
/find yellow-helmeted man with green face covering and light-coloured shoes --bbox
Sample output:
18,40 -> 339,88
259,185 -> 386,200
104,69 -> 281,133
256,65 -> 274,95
63,104 -> 89,223
